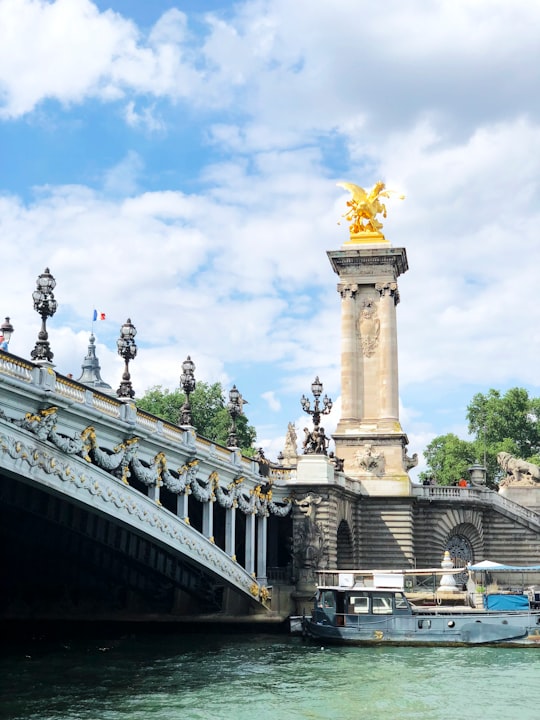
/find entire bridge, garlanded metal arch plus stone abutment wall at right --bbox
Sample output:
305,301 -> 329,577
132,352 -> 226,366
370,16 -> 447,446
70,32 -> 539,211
0,352 -> 540,623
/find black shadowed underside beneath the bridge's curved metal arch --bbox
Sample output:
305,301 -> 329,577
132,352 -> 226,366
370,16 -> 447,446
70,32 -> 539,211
0,472 -> 270,622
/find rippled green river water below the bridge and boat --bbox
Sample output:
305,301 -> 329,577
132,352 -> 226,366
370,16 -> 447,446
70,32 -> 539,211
0,631 -> 540,720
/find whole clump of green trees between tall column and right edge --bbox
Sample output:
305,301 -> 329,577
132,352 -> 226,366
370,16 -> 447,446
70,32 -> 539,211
420,388 -> 540,486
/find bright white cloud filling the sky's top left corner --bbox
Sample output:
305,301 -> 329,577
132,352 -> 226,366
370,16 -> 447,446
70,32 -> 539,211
0,0 -> 199,119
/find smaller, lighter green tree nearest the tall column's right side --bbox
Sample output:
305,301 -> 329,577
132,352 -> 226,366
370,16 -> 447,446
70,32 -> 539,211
419,433 -> 476,485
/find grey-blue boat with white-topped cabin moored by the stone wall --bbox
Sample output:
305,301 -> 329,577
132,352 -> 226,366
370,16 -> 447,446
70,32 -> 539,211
303,569 -> 540,648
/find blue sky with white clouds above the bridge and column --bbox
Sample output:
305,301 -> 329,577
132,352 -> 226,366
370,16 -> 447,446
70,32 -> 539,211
0,0 -> 540,484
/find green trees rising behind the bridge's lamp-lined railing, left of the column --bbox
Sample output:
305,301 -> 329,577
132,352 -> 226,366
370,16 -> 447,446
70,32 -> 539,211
137,381 -> 257,456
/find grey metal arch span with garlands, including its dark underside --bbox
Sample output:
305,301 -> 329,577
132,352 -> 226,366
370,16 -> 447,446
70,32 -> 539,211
0,352 -> 292,621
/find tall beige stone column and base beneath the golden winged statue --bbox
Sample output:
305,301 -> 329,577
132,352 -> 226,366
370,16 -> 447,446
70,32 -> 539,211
328,242 -> 416,496
